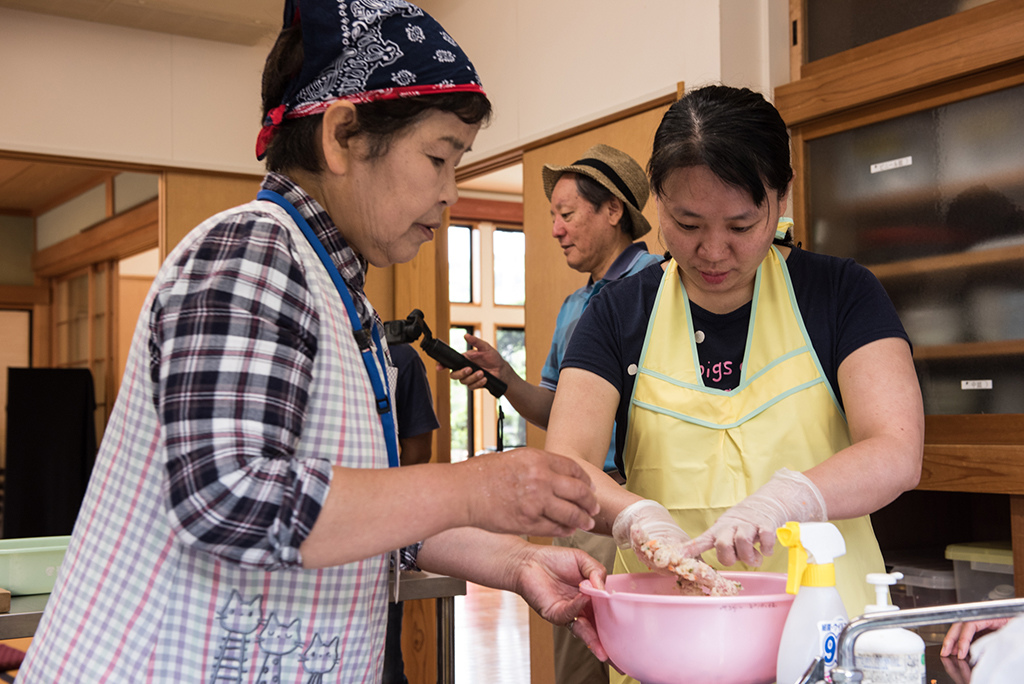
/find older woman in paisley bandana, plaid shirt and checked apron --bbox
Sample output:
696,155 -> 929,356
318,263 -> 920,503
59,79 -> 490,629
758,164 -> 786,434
18,0 -> 604,684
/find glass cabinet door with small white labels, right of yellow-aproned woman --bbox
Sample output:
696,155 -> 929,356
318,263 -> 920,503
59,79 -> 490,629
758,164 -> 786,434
806,86 -> 1024,414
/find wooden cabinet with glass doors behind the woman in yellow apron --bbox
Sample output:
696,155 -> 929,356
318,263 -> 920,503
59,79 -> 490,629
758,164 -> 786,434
775,0 -> 1024,595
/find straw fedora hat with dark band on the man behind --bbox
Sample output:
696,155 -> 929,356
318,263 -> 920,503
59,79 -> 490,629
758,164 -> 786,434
543,144 -> 650,240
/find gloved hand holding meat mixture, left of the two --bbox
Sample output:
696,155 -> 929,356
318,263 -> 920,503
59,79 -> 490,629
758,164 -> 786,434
611,499 -> 692,571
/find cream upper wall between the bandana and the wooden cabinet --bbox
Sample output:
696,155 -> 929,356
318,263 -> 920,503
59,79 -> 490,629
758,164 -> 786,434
419,0 -> 788,162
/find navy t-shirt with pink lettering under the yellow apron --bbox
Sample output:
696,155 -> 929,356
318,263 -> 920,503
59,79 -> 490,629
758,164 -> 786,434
562,248 -> 909,469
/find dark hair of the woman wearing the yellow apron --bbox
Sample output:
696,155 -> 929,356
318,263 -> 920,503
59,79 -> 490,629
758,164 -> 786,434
647,85 -> 793,207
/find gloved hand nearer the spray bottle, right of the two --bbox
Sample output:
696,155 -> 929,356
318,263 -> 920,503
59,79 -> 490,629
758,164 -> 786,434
684,468 -> 828,567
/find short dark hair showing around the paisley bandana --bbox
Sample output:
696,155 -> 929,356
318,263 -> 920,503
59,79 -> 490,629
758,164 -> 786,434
262,26 -> 490,173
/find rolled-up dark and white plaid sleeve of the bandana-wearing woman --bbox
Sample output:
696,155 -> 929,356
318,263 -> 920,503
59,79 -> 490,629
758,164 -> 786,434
148,214 -> 332,569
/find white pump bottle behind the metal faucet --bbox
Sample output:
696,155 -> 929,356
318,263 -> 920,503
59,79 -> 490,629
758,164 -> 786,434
853,572 -> 926,684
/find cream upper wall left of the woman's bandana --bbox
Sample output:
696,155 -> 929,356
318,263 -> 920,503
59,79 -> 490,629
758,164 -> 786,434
0,8 -> 269,173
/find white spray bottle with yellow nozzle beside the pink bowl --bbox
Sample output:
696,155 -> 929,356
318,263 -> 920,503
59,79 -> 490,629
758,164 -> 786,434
775,522 -> 849,684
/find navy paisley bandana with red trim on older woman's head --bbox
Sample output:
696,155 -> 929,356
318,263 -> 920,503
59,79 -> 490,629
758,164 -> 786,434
256,0 -> 483,159
